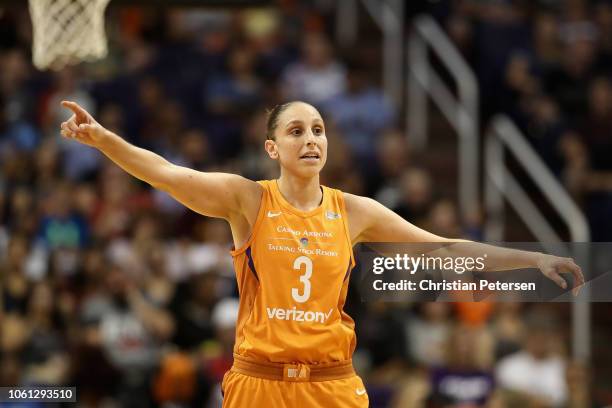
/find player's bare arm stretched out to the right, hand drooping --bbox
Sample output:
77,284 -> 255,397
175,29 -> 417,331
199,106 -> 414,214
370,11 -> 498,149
344,193 -> 584,295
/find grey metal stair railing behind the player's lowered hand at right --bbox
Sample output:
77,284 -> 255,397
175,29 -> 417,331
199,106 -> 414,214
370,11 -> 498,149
484,115 -> 591,361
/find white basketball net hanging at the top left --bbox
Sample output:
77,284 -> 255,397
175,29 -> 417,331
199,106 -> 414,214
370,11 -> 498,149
30,0 -> 110,70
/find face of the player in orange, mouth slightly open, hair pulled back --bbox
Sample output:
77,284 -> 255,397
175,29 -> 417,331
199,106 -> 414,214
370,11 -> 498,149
266,102 -> 327,177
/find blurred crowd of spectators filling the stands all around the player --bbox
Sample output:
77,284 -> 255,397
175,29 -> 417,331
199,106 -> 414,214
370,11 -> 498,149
0,0 -> 612,407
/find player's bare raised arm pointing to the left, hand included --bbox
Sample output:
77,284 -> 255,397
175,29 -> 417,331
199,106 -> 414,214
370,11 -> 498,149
61,101 -> 261,219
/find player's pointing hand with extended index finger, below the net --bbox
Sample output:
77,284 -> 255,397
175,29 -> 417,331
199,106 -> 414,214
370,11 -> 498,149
61,101 -> 108,147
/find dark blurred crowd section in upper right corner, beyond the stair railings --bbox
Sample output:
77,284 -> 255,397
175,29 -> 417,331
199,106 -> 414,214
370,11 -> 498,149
438,0 -> 612,241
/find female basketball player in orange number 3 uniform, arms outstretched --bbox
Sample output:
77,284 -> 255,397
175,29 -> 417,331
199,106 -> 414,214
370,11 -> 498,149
61,102 -> 583,408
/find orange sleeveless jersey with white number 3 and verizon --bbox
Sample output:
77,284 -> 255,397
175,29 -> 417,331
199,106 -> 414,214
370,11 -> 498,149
232,180 -> 355,364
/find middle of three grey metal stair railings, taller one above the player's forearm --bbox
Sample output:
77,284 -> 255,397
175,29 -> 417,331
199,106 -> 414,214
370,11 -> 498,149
405,16 -> 479,223
